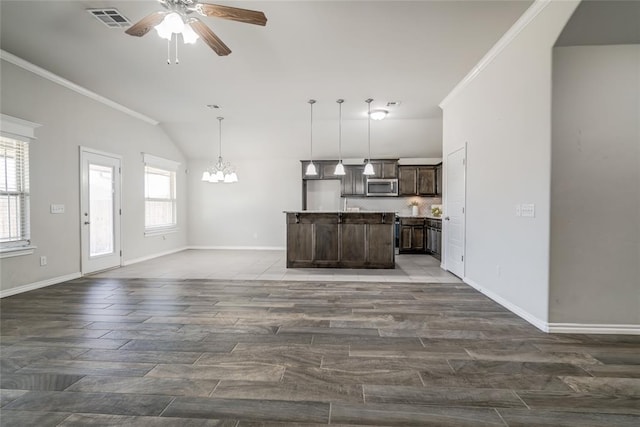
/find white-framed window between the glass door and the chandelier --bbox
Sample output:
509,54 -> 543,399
144,154 -> 178,235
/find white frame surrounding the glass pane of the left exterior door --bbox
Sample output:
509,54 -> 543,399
79,146 -> 122,276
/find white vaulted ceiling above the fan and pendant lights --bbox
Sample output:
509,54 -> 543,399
0,0 -> 531,158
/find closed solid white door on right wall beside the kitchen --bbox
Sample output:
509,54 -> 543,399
444,147 -> 466,278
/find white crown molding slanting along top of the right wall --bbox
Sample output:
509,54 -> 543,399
438,0 -> 553,109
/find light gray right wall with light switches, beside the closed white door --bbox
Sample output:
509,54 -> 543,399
443,2 -> 577,326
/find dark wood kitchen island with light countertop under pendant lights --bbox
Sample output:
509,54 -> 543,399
285,211 -> 395,268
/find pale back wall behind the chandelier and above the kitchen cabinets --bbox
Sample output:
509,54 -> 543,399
188,116 -> 442,248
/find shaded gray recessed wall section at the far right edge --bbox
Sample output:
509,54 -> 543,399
550,45 -> 640,325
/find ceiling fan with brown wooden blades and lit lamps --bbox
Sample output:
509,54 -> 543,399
125,0 -> 267,56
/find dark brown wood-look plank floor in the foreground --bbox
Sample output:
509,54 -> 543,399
0,278 -> 640,427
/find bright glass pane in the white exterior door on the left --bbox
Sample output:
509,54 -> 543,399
88,164 -> 114,257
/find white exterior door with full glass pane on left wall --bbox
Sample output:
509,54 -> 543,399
80,147 -> 122,275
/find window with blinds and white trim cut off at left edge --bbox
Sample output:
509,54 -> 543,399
0,114 -> 40,258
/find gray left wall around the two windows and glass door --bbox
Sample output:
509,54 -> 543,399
0,61 -> 187,292
